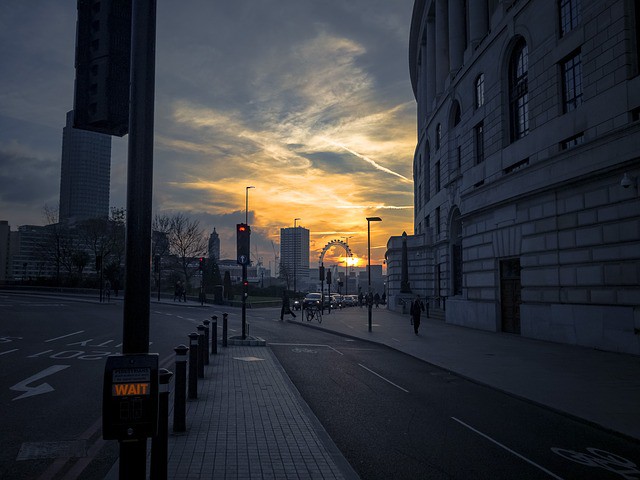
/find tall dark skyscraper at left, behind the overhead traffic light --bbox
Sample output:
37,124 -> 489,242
59,111 -> 111,222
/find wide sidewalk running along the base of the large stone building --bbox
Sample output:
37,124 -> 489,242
292,307 -> 640,439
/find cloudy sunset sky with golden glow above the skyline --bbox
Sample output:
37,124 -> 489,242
0,0 -> 416,274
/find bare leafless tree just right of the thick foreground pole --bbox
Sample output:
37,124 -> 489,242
169,213 -> 207,284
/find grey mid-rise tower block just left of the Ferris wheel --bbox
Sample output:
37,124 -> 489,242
280,227 -> 309,291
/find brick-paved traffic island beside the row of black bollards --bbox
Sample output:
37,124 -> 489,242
162,346 -> 358,480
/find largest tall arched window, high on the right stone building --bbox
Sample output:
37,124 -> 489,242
509,39 -> 529,141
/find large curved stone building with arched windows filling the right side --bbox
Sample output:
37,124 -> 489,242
387,0 -> 640,354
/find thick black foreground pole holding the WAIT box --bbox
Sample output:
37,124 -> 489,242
119,0 -> 156,480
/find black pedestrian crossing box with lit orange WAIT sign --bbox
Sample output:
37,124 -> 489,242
102,354 -> 158,440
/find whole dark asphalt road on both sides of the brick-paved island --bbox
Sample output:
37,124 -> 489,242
0,294 -> 640,479
